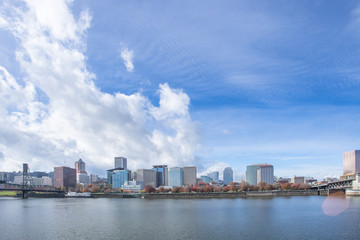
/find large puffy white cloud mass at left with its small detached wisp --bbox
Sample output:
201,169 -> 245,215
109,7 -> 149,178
0,1 -> 200,174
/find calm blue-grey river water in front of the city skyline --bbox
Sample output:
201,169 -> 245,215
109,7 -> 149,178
0,196 -> 360,240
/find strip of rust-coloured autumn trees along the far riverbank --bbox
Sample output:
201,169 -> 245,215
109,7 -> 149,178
0,182 -> 338,199
